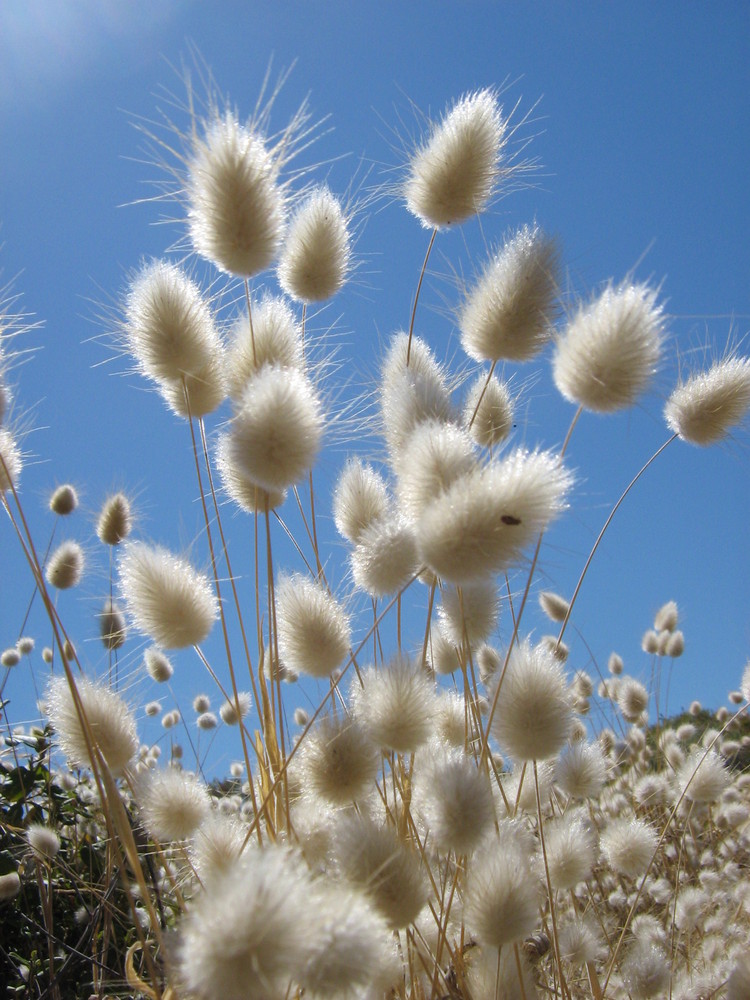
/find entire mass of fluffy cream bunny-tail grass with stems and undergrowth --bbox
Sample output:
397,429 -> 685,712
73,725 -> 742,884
0,60 -> 750,1000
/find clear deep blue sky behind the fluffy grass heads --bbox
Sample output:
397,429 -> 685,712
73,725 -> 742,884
0,0 -> 750,772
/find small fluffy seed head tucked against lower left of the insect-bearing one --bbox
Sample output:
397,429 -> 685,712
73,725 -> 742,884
351,516 -> 418,597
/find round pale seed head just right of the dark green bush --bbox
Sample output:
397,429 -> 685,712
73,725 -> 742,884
136,768 -> 211,844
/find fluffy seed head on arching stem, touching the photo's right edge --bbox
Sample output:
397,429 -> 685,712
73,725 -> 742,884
664,355 -> 750,446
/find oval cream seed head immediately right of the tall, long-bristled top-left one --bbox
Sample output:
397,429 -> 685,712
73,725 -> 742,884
278,187 -> 351,302
